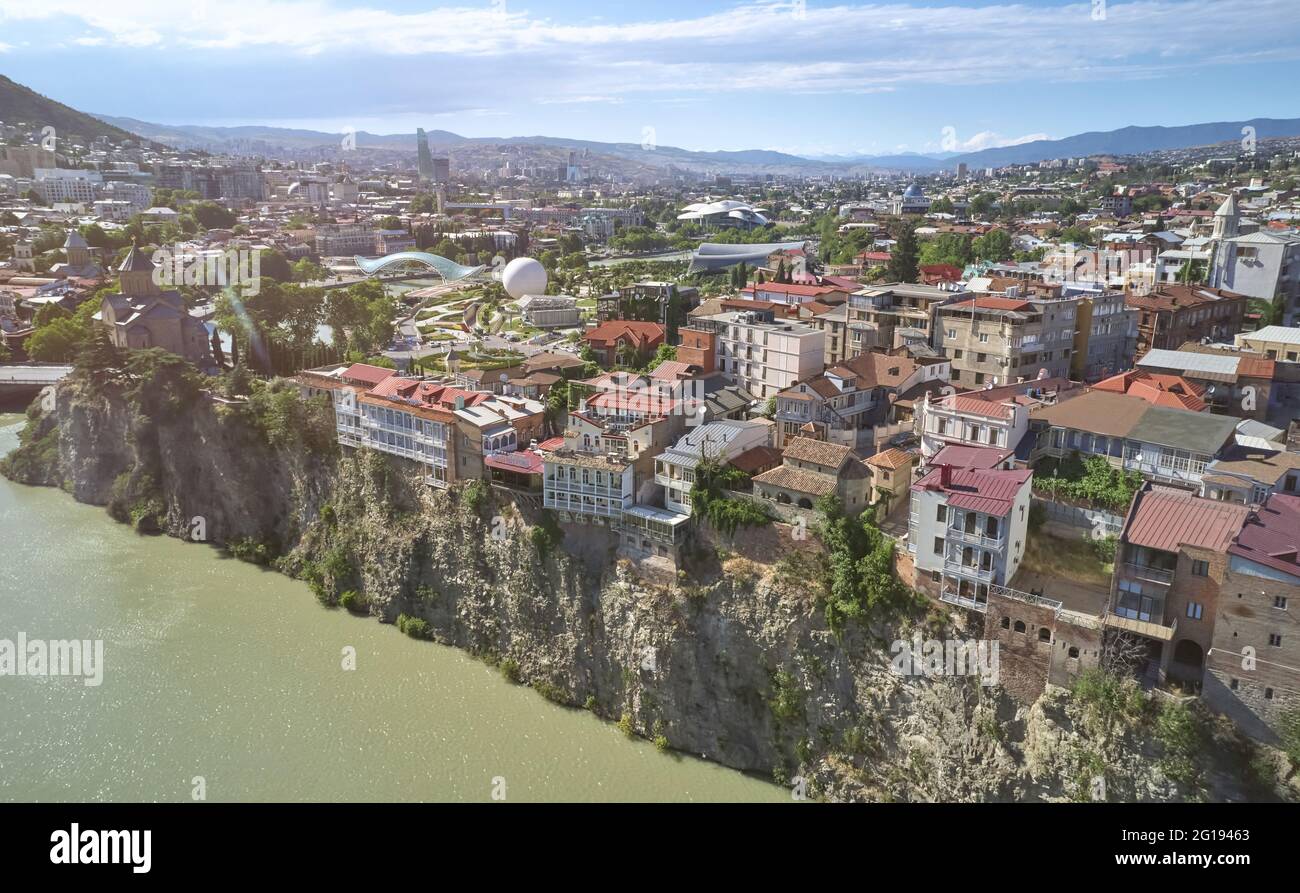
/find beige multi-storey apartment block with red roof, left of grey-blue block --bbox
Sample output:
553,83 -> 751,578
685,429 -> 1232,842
936,296 -> 1079,387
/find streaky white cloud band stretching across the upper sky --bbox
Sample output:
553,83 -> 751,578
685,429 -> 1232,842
0,0 -> 1300,101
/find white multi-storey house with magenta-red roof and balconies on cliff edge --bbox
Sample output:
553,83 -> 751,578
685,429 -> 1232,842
907,464 -> 1034,611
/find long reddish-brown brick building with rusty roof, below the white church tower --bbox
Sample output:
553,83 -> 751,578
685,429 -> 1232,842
1125,285 -> 1247,357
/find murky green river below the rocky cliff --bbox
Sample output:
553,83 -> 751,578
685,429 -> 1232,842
0,413 -> 790,802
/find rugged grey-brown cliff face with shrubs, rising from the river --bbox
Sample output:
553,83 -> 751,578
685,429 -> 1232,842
4,369 -> 1284,801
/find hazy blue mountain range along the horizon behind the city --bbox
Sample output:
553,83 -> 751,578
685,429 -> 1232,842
0,75 -> 1300,174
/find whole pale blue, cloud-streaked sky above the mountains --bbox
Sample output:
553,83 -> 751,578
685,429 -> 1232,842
0,0 -> 1300,156
